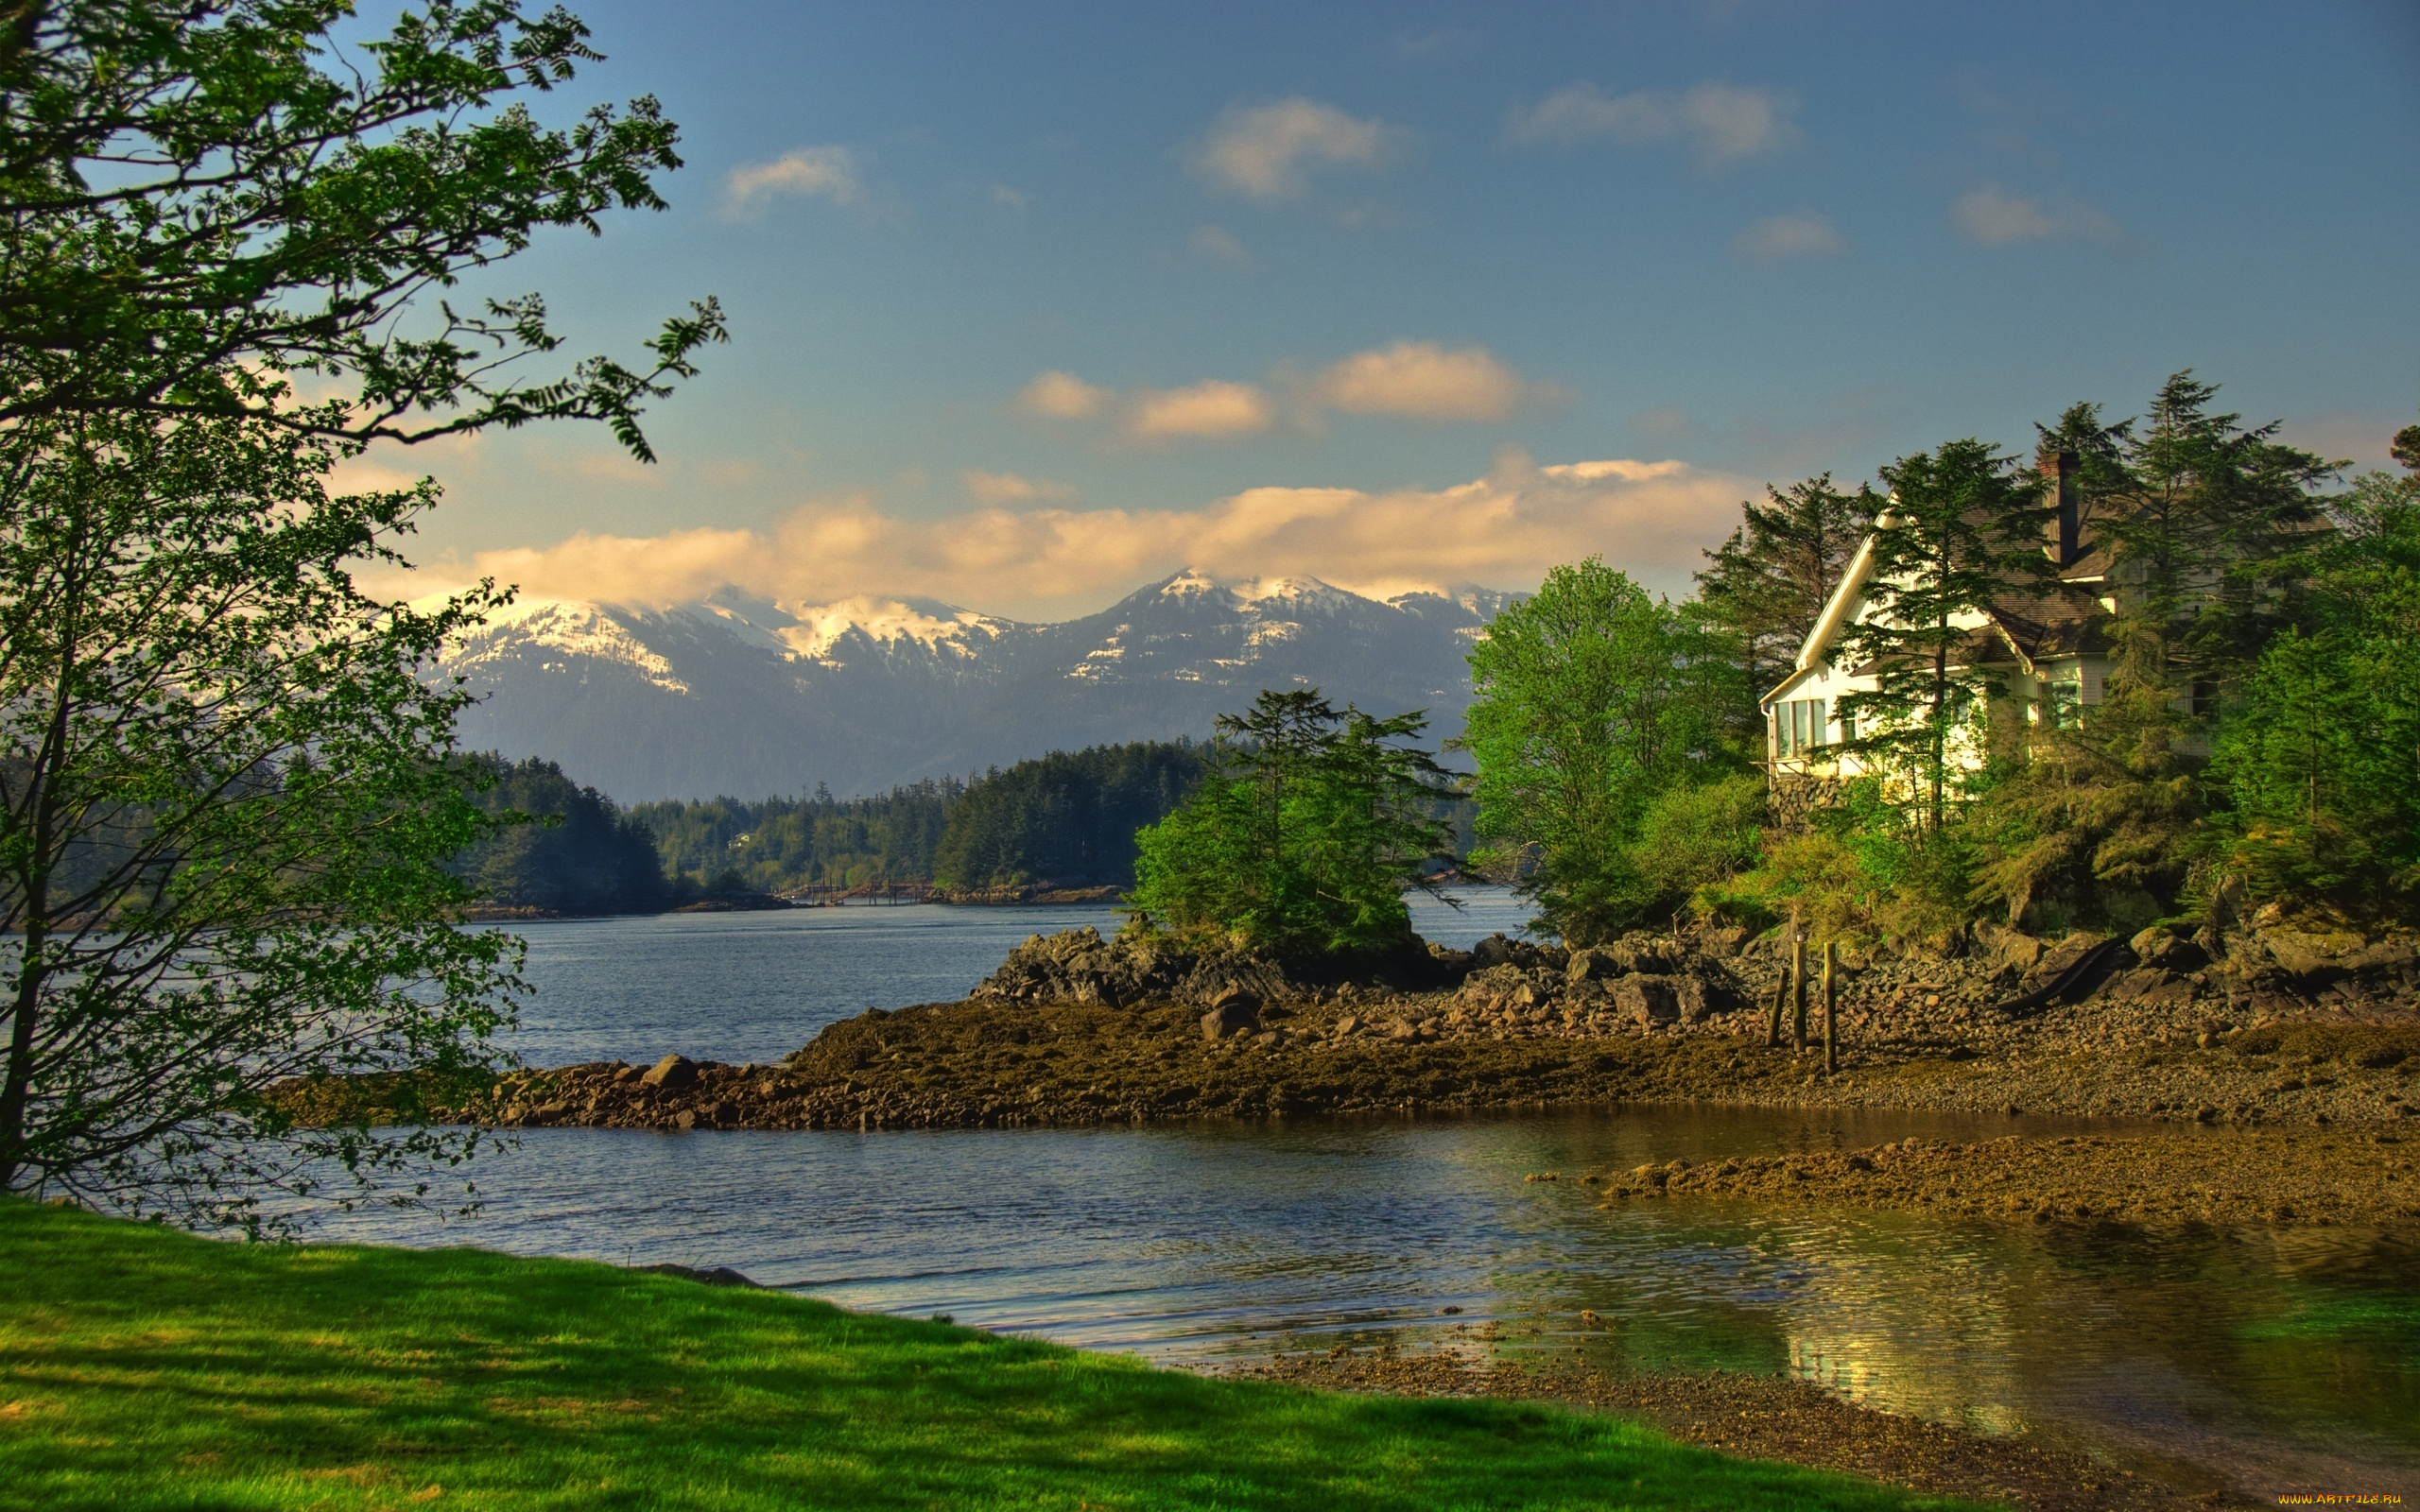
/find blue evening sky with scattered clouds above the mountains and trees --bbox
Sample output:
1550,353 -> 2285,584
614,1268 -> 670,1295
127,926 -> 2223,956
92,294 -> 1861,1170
349,0 -> 2420,619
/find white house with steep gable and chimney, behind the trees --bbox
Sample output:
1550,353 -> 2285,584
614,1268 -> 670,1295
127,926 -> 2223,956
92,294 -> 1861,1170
1762,453 -> 2118,779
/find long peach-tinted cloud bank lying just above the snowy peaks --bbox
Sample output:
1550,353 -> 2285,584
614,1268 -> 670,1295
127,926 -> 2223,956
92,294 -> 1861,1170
445,450 -> 1754,617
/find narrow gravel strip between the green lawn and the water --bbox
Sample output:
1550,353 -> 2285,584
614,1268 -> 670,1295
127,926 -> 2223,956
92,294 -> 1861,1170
1227,1352 -> 2216,1512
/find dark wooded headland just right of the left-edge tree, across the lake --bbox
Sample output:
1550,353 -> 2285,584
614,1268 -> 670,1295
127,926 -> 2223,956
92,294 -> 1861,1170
450,755 -> 673,915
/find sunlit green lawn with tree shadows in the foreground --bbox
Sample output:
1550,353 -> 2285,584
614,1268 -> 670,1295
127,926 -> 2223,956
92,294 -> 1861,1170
0,1200 -> 1994,1512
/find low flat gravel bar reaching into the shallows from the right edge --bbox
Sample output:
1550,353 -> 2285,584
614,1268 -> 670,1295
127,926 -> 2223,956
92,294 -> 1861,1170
1587,1130 -> 2420,1224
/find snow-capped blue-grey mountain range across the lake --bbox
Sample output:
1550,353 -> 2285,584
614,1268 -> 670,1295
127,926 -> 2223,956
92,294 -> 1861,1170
445,571 -> 1508,803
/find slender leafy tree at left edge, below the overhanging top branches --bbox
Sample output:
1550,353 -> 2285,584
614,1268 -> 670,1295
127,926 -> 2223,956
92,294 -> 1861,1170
0,404 -> 518,1227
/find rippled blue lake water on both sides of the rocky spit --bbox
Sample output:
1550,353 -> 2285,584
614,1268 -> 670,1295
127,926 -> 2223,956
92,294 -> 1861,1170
329,895 -> 2420,1495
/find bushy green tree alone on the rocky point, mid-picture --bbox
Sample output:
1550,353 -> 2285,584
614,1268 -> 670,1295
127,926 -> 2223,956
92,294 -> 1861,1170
1128,690 -> 1452,954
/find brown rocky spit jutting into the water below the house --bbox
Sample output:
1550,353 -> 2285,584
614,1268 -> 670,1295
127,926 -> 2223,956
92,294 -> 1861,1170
387,914 -> 2420,1151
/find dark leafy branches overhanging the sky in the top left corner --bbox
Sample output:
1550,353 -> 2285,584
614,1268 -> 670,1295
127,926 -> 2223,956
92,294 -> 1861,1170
0,0 -> 723,459
